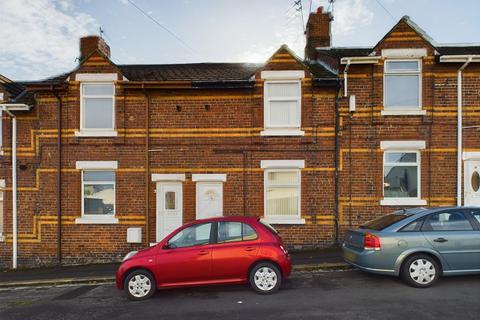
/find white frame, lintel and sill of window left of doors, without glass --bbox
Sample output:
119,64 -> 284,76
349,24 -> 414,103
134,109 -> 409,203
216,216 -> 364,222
75,161 -> 118,224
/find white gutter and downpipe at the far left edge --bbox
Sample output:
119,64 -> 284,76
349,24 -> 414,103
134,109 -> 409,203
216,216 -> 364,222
0,103 -> 30,269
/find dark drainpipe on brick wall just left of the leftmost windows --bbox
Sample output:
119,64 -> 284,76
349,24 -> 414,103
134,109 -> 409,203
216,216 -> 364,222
52,88 -> 62,265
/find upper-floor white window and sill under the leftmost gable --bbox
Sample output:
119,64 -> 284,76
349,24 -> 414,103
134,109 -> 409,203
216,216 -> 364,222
76,82 -> 117,137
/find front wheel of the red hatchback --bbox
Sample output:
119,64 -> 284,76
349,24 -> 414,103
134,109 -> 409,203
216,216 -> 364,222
124,270 -> 157,301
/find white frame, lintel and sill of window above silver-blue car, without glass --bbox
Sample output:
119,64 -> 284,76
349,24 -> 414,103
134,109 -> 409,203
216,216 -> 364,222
380,141 -> 427,206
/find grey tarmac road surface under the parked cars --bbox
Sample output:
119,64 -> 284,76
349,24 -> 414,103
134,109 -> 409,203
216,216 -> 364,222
0,269 -> 480,320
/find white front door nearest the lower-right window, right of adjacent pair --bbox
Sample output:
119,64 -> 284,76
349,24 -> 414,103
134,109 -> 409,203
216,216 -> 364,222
197,182 -> 223,219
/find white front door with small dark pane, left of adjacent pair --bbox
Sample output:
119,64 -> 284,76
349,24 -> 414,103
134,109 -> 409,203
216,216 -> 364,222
157,182 -> 183,242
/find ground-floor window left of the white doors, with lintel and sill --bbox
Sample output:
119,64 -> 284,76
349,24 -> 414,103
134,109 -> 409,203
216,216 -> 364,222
76,161 -> 118,224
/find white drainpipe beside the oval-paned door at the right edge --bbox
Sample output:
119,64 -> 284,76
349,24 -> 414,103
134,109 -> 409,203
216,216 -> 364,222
457,56 -> 472,206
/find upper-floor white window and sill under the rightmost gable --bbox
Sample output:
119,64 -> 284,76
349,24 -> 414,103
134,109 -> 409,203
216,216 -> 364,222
382,59 -> 425,115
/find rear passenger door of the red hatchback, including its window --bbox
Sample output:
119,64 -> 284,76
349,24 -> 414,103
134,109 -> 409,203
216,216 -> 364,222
212,221 -> 259,281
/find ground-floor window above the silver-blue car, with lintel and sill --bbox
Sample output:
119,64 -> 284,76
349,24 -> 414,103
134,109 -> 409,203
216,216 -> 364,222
381,141 -> 426,205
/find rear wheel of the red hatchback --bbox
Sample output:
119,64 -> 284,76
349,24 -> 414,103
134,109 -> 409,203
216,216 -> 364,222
249,262 -> 282,294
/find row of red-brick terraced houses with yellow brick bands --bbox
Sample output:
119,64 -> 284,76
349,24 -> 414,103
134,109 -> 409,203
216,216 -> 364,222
0,9 -> 480,268
